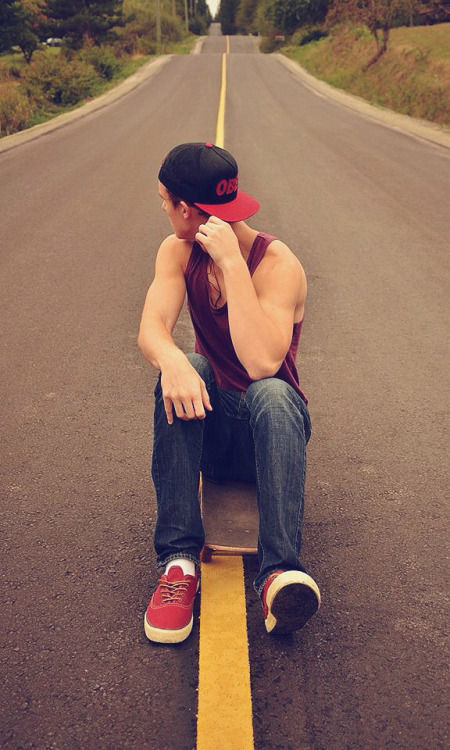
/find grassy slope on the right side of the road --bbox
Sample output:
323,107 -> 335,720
281,24 -> 450,125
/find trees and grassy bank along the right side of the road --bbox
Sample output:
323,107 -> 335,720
218,0 -> 450,125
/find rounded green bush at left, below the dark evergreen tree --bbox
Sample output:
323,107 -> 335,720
25,54 -> 100,106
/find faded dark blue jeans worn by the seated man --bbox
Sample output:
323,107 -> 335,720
152,354 -> 311,594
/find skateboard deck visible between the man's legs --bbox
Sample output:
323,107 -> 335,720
200,477 -> 259,562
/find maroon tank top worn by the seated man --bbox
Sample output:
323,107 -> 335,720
185,232 -> 308,404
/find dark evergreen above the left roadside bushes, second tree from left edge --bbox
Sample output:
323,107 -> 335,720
47,0 -> 123,49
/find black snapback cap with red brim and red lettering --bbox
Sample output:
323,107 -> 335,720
158,143 -> 259,222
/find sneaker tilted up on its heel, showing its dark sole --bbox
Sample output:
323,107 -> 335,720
262,570 -> 320,635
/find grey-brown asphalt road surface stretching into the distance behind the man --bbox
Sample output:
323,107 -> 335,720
0,26 -> 450,750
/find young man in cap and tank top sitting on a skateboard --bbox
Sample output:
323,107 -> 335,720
139,143 -> 320,643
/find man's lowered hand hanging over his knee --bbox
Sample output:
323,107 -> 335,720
161,354 -> 212,424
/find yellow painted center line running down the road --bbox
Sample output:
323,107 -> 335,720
197,42 -> 254,750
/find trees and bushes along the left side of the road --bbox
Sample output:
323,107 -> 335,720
0,0 -> 211,137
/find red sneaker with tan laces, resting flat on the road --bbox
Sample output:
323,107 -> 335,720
144,565 -> 199,643
